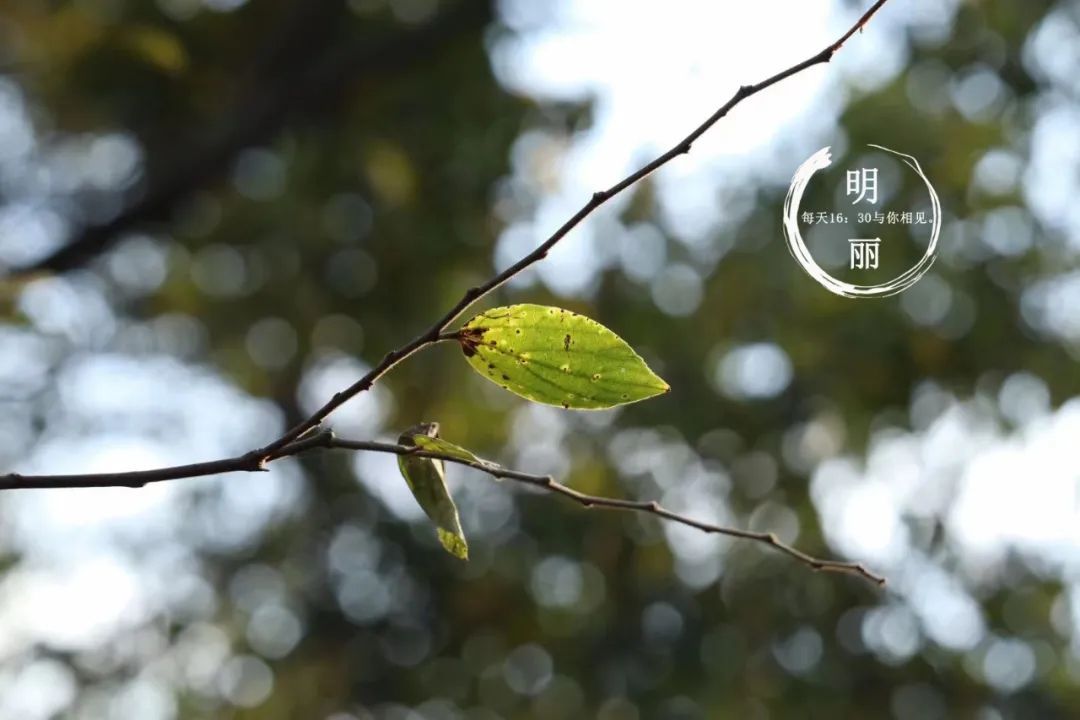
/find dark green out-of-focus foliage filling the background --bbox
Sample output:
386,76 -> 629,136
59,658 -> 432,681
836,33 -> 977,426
0,0 -> 1080,720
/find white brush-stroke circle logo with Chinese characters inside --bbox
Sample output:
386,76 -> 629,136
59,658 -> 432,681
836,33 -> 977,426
784,145 -> 941,298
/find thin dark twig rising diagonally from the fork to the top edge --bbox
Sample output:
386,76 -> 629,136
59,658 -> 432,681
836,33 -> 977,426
248,0 -> 888,460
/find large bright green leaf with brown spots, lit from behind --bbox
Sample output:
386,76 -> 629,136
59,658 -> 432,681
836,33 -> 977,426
459,304 -> 670,410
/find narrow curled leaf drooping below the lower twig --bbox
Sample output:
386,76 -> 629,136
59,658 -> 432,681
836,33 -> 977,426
397,422 -> 472,560
